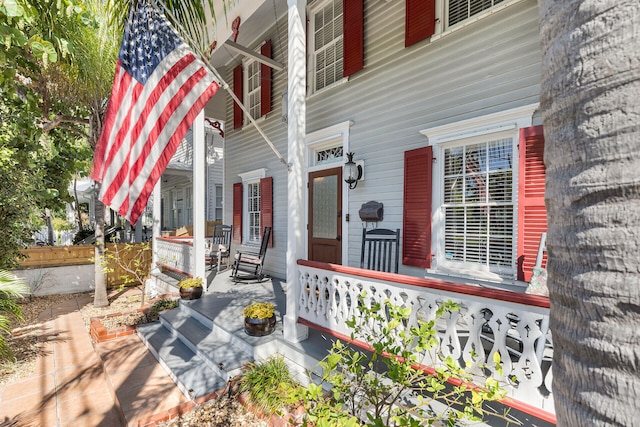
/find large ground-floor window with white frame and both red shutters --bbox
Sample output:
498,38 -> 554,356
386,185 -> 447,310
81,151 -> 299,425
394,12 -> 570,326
410,105 -> 547,281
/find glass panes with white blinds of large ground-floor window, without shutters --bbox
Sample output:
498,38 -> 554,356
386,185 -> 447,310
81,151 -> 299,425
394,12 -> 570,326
442,138 -> 515,268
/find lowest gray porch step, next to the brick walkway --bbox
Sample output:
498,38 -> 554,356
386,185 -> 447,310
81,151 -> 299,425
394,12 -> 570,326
138,322 -> 226,399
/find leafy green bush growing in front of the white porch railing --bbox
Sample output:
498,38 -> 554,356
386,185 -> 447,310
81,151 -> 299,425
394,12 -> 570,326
290,293 -> 506,427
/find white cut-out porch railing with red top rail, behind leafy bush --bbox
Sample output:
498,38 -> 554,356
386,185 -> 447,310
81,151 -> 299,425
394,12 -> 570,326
297,261 -> 555,422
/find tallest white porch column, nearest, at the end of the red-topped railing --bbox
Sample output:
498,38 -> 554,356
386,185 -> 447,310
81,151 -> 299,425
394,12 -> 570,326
284,0 -> 309,342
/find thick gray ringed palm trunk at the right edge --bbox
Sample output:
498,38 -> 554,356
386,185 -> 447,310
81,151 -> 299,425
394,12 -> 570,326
539,0 -> 640,426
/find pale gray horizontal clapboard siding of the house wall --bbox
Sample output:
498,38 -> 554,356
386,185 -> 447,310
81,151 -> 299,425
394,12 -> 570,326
225,0 -> 541,277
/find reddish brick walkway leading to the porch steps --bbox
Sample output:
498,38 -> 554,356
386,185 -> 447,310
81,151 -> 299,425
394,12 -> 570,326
0,296 -> 188,427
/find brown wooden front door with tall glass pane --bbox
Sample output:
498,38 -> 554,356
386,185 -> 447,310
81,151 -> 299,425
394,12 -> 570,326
308,167 -> 342,264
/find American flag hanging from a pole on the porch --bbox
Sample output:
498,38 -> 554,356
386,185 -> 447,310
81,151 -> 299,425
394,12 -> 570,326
91,0 -> 219,224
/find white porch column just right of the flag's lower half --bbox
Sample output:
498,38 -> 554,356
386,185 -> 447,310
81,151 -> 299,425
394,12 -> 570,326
192,110 -> 207,290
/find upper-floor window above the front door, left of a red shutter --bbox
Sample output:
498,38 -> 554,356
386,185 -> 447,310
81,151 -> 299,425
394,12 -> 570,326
310,0 -> 343,92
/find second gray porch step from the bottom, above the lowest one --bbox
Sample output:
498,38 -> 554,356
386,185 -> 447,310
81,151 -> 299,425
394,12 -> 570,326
160,310 -> 253,380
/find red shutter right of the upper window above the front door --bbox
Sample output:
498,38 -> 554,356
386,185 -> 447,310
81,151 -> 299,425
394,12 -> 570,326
342,0 -> 364,77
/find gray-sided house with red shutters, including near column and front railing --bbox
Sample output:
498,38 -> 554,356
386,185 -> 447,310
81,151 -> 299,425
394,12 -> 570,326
152,0 -> 555,420
